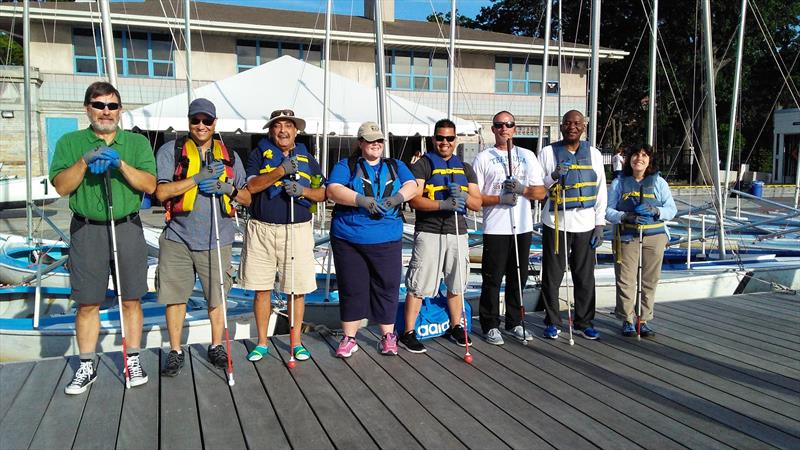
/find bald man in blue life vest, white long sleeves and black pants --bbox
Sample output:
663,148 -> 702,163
539,110 -> 607,339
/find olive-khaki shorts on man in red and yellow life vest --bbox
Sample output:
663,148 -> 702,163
156,233 -> 233,308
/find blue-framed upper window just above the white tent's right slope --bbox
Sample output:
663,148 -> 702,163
386,50 -> 447,91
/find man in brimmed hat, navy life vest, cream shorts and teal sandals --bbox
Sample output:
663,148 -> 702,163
240,109 -> 325,361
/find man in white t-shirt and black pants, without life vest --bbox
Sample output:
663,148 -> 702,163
473,111 -> 547,345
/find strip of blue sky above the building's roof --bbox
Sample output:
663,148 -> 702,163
203,0 -> 492,20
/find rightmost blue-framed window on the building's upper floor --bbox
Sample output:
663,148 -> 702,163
494,56 -> 559,95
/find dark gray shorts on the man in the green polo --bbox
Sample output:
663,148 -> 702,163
69,216 -> 147,305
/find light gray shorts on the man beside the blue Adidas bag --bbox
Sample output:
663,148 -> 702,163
406,231 -> 469,297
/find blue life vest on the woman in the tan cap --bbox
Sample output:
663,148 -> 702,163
333,156 -> 402,220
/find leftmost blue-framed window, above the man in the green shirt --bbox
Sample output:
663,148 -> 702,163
72,29 -> 175,78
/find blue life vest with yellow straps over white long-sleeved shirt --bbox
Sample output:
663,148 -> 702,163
550,141 -> 597,211
